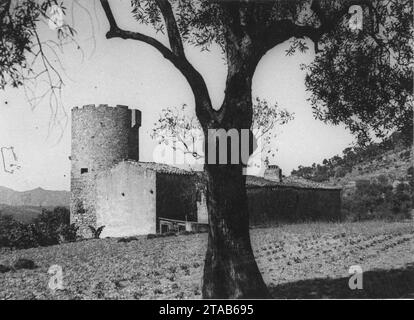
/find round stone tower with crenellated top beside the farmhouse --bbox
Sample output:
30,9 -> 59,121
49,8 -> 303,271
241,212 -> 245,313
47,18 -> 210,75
70,105 -> 141,237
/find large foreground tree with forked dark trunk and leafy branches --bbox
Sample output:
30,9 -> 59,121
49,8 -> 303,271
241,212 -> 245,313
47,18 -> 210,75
0,0 -> 413,298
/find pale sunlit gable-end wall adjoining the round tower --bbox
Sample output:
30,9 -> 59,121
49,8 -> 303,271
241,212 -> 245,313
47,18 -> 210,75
96,161 -> 157,237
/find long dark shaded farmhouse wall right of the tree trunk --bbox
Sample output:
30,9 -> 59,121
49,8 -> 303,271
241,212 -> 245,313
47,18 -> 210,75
247,186 -> 341,226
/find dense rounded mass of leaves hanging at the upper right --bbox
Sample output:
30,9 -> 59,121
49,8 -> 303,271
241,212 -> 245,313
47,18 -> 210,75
305,1 -> 414,144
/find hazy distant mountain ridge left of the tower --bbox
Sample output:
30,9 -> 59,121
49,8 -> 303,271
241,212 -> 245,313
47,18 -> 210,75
0,187 -> 70,208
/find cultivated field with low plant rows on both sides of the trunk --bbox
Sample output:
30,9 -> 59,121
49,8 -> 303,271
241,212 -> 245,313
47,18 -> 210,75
0,222 -> 414,299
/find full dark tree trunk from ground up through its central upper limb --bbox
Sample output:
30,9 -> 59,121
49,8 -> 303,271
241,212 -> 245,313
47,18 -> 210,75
200,20 -> 270,299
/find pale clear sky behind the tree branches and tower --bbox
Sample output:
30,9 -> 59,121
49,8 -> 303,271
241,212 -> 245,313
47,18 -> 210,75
0,0 -> 354,191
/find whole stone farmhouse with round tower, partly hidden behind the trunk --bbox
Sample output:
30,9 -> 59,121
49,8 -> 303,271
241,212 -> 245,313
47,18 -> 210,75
70,105 -> 341,238
